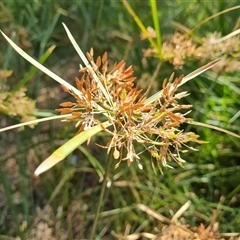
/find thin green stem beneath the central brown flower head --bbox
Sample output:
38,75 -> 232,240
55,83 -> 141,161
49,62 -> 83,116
90,150 -> 113,240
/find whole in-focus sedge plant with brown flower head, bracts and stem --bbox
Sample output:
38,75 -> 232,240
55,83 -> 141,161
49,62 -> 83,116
0,21 -> 239,239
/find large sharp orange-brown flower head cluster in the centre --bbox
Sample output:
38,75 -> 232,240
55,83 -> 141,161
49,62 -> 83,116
57,50 -> 202,171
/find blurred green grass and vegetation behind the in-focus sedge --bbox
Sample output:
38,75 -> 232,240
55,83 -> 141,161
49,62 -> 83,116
0,0 -> 240,239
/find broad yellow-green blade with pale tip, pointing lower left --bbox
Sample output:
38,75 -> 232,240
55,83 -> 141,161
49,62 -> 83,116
34,121 -> 111,176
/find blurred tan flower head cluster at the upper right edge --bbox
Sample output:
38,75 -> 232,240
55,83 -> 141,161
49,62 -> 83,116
141,27 -> 240,73
